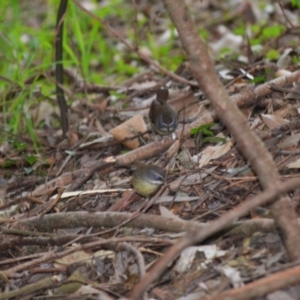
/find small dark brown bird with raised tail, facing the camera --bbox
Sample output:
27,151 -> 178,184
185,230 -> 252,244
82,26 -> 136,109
149,89 -> 178,135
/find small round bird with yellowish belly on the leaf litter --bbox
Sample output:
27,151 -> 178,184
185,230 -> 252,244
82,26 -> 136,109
131,165 -> 166,198
